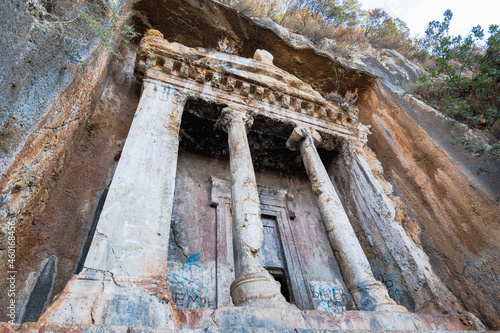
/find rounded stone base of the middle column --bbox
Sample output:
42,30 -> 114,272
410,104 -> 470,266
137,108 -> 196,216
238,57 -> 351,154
231,273 -> 292,308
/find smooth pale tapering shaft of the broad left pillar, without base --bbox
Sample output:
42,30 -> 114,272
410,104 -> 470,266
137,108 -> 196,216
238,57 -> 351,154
85,80 -> 186,282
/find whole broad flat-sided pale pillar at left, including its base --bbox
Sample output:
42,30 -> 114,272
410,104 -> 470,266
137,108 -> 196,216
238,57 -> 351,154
42,80 -> 186,328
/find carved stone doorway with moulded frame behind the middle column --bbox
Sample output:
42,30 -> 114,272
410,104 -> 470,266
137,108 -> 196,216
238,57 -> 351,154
211,177 -> 313,309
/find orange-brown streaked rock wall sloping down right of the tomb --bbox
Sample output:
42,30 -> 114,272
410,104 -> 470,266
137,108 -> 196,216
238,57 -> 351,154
359,85 -> 500,328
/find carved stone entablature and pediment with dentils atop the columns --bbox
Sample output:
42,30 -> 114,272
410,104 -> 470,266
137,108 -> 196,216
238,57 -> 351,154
135,36 -> 366,141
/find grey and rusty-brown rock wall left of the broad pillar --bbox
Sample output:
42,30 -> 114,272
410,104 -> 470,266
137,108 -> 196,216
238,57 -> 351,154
0,1 -> 143,321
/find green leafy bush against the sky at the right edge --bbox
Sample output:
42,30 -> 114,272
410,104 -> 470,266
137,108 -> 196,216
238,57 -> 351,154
414,10 -> 500,129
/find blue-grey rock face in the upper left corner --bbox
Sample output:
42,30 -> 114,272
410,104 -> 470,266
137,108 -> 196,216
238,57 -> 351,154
0,0 -> 73,173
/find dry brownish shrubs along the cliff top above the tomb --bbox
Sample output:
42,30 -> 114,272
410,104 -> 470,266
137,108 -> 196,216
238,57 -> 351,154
221,0 -> 417,54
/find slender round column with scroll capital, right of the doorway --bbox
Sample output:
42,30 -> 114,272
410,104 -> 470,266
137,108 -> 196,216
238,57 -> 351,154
287,127 -> 406,312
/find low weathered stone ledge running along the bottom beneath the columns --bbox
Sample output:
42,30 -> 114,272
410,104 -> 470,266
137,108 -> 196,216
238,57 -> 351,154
0,307 -> 477,333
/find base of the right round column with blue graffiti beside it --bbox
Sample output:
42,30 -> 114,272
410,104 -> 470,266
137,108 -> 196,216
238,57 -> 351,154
350,281 -> 408,312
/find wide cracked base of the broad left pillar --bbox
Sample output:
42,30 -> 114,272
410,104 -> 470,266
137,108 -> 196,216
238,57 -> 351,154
39,270 -> 174,329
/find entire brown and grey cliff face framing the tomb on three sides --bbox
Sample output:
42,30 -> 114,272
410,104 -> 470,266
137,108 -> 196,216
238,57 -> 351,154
0,0 -> 500,329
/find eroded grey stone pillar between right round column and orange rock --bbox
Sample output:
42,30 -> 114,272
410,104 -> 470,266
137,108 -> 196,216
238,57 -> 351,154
329,143 -> 476,313
